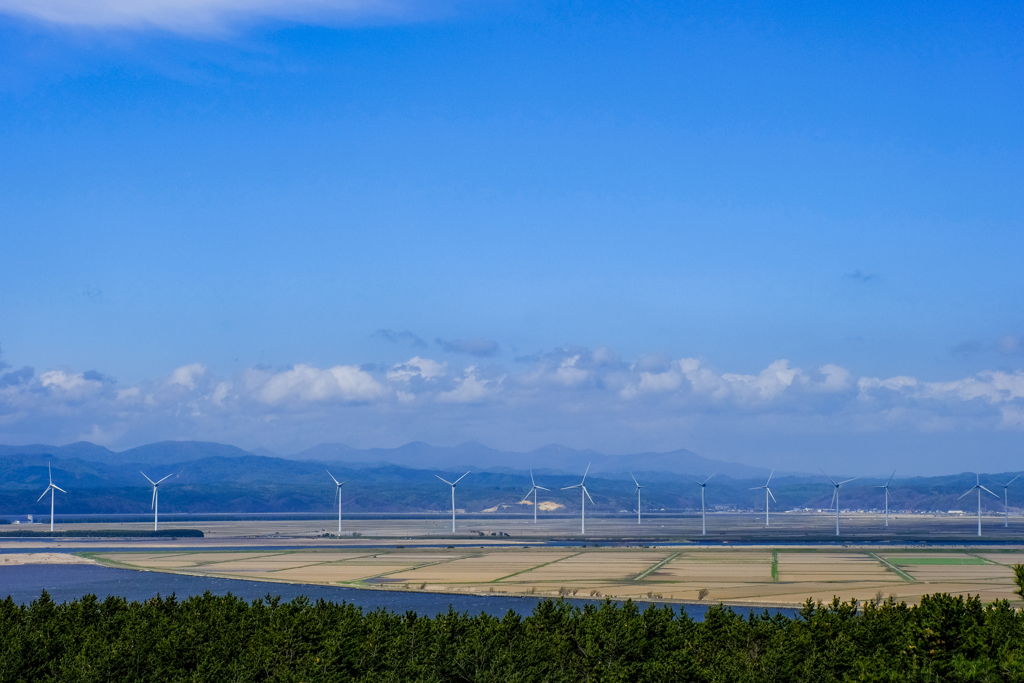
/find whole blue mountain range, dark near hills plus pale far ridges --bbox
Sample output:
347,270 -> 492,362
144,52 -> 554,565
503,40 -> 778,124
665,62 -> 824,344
0,441 -> 1024,515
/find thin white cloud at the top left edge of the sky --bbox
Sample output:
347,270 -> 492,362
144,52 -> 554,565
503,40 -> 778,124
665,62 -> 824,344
0,0 -> 436,34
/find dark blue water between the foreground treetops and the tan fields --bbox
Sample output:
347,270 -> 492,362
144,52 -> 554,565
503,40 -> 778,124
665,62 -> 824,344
0,564 -> 797,620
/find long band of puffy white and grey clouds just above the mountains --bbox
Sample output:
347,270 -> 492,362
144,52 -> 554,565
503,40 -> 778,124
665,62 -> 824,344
0,348 -> 1024,462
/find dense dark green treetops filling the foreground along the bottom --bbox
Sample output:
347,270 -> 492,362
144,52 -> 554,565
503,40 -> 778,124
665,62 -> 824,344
6,593 -> 1024,683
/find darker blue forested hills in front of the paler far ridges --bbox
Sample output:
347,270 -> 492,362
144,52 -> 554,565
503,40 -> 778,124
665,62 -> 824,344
0,446 -> 1024,515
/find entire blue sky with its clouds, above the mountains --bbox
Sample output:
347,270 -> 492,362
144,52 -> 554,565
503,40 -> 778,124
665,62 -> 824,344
0,0 -> 1024,472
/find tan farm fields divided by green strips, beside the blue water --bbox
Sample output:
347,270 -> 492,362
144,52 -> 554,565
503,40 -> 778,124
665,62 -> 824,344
90,547 -> 1024,606
